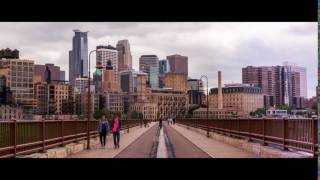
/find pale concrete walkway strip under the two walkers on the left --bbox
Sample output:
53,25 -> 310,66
67,122 -> 157,158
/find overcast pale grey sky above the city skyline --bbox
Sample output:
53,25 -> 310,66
0,22 -> 318,97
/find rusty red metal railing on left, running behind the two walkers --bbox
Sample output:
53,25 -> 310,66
0,120 -> 143,158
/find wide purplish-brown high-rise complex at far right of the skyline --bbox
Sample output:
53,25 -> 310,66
242,65 -> 307,106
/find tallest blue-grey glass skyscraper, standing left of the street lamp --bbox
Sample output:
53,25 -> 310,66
69,30 -> 88,85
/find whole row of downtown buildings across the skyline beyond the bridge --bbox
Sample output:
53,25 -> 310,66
0,30 -> 316,120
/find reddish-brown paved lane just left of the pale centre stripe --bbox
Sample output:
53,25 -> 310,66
115,123 -> 158,158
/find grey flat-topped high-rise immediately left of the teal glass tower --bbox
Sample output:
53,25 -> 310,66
139,55 -> 159,88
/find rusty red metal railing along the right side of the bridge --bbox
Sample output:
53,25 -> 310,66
177,118 -> 318,156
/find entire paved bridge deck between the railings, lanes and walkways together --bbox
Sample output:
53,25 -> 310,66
68,122 -> 256,158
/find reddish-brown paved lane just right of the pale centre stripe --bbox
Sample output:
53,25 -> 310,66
164,123 -> 211,158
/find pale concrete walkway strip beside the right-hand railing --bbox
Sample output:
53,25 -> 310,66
170,124 -> 257,158
